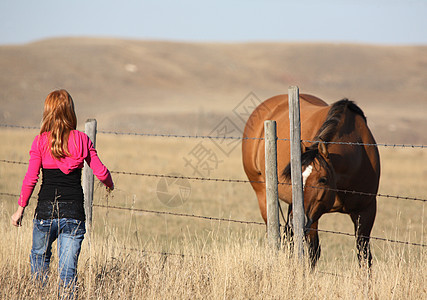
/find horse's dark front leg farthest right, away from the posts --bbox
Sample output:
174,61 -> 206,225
350,200 -> 377,268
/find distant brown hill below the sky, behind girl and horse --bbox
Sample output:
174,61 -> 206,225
0,38 -> 427,144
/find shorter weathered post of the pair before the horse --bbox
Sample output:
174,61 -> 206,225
264,120 -> 280,250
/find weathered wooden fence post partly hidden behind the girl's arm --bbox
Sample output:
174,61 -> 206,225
82,119 -> 96,236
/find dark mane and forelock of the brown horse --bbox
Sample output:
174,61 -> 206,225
283,98 -> 366,179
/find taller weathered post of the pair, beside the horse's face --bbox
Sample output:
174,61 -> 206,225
288,86 -> 305,259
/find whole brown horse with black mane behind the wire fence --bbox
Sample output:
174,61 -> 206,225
242,94 -> 380,266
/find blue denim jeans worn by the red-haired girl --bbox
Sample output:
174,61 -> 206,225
30,218 -> 86,296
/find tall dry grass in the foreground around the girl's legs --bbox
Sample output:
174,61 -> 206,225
0,217 -> 426,299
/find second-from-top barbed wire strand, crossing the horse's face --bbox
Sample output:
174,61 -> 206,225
0,159 -> 427,202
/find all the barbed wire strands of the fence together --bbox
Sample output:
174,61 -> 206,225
0,124 -> 427,256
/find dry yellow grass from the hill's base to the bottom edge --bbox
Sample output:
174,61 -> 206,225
0,130 -> 427,299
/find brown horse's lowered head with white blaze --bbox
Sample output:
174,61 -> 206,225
283,142 -> 336,232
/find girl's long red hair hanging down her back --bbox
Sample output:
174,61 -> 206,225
40,89 -> 77,159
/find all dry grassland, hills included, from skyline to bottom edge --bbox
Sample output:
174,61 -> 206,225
0,38 -> 427,299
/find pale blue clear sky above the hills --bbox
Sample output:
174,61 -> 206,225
0,0 -> 427,45
